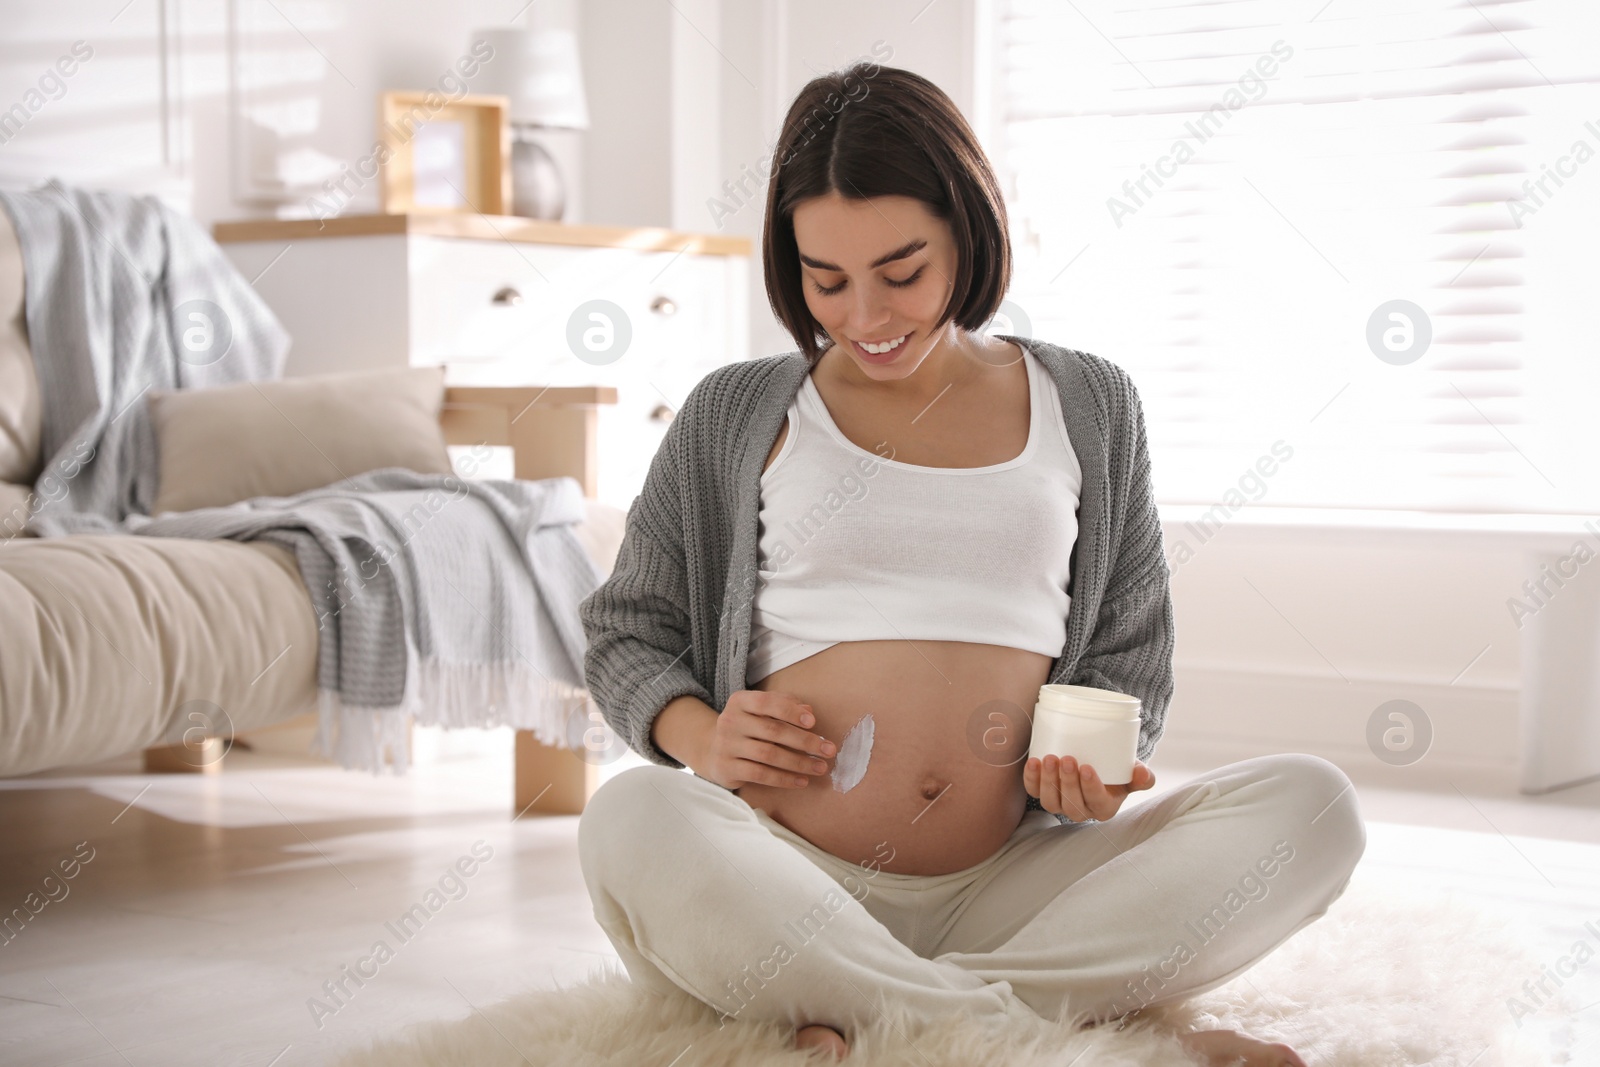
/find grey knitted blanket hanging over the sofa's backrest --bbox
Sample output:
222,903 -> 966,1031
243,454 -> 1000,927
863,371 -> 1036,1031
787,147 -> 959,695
0,181 -> 290,536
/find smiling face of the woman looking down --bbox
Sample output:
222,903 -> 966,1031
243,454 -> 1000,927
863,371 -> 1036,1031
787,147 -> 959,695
794,192 -> 955,381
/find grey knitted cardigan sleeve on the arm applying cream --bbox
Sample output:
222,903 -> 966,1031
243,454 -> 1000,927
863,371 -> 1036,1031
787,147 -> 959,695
578,395 -> 712,768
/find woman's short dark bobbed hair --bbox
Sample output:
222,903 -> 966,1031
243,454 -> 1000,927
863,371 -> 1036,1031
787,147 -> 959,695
762,61 -> 1011,363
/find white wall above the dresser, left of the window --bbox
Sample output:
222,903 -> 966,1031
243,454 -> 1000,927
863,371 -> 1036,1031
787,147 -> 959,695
0,0 -> 974,363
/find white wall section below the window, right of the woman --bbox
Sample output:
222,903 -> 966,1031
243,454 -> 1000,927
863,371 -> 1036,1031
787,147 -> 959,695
1160,514 -> 1525,789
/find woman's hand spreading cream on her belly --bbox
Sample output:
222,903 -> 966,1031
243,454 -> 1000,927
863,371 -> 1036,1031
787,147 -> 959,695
694,689 -> 838,790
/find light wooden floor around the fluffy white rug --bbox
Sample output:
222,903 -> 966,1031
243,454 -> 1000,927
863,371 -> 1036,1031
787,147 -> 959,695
0,731 -> 1600,1067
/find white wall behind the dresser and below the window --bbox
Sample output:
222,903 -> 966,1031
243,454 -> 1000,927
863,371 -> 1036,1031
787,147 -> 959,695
0,0 -> 1568,793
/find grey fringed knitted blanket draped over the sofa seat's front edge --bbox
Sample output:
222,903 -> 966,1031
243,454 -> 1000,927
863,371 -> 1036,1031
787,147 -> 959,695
123,467 -> 600,773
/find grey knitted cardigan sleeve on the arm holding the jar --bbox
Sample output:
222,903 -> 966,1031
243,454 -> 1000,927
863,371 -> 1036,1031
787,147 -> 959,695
1070,373 -> 1174,760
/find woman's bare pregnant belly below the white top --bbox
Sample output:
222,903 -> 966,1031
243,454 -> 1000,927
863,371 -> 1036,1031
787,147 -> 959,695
734,640 -> 1051,875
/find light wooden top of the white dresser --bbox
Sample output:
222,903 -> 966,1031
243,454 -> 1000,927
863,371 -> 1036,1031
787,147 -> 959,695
211,213 -> 750,256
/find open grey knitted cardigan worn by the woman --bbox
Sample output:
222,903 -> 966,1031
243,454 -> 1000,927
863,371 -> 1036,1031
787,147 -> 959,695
579,334 -> 1173,817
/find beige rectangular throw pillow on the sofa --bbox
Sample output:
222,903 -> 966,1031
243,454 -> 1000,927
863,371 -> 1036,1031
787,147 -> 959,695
149,366 -> 451,515
